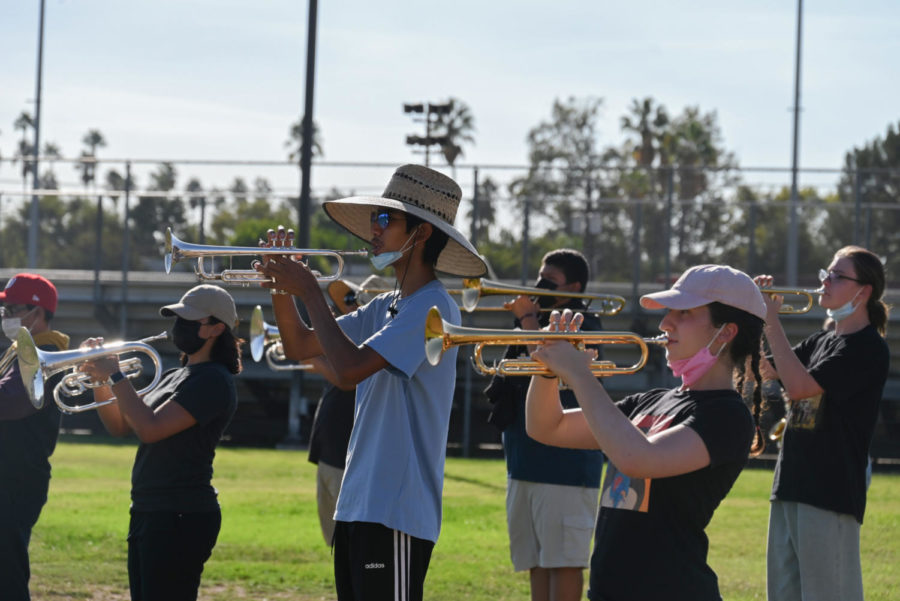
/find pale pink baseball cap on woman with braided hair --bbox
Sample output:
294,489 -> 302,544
641,265 -> 766,319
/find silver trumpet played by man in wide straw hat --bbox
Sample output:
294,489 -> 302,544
165,228 -> 369,286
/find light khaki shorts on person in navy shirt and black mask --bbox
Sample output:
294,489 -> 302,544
506,479 -> 600,572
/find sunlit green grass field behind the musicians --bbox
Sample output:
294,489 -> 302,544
31,442 -> 900,601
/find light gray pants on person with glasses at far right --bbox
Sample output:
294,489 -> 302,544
766,501 -> 863,601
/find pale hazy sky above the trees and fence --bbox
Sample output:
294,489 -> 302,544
0,0 -> 900,200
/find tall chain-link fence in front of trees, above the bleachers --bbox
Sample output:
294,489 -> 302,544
0,159 -> 900,286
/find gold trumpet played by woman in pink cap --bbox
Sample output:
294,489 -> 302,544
425,307 -> 667,378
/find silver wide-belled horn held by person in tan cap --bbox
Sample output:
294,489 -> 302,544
16,328 -> 168,414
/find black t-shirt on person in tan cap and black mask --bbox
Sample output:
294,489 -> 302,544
131,361 -> 237,512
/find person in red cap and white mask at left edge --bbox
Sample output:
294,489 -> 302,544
0,273 -> 69,601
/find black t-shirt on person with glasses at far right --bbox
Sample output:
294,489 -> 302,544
772,325 -> 890,524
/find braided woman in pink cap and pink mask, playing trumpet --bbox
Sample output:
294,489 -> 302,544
525,265 -> 766,601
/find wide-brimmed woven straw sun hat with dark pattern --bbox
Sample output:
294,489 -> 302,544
324,165 -> 487,277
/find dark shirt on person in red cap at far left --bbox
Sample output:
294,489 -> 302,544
0,345 -> 62,491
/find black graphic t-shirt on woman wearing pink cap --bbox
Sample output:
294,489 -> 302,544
588,389 -> 754,601
